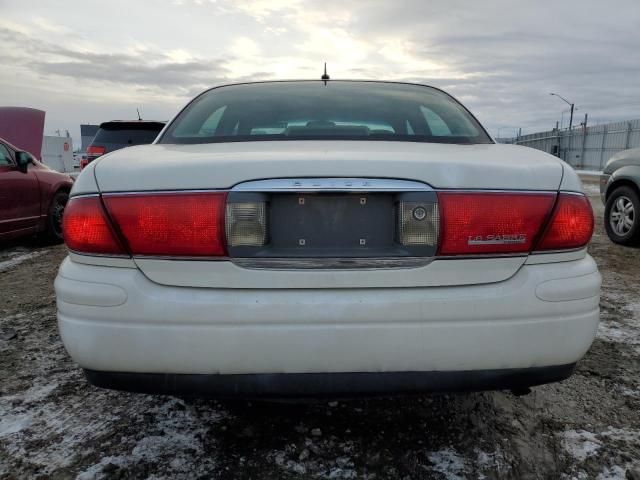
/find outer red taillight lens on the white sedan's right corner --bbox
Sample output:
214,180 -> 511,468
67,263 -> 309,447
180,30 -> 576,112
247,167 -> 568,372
536,193 -> 593,250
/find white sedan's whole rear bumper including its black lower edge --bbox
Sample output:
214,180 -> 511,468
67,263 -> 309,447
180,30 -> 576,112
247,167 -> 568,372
55,256 -> 600,394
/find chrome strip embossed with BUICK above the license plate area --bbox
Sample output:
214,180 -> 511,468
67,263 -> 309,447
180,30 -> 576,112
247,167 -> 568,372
231,177 -> 433,192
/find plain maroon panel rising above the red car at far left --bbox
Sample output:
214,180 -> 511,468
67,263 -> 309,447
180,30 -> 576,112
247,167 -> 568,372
0,107 -> 45,160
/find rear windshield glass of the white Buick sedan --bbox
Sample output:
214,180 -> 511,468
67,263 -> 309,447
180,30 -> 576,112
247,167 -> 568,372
159,80 -> 492,144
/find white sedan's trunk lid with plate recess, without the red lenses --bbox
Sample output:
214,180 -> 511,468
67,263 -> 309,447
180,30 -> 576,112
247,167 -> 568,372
91,141 -> 562,289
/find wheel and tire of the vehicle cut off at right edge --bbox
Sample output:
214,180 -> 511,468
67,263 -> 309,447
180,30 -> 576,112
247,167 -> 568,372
604,186 -> 640,246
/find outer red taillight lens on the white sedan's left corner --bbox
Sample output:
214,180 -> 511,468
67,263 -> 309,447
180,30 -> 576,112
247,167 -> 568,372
62,197 -> 125,255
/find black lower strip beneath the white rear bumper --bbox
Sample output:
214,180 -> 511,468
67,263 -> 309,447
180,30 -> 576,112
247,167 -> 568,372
85,364 -> 575,398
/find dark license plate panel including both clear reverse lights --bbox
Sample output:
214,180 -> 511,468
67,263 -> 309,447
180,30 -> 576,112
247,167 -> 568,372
225,191 -> 439,260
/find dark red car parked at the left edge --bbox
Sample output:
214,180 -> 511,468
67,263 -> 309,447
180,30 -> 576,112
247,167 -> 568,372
0,138 -> 73,242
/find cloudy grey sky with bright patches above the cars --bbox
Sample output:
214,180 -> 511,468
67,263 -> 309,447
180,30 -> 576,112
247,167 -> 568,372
0,0 -> 640,143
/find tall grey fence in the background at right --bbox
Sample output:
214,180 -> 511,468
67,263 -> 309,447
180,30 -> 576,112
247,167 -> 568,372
513,119 -> 640,170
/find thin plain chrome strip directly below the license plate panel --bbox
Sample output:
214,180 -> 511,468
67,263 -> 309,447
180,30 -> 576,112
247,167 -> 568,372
230,257 -> 434,270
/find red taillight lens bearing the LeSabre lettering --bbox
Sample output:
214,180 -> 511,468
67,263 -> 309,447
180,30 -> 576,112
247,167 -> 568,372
438,192 -> 556,255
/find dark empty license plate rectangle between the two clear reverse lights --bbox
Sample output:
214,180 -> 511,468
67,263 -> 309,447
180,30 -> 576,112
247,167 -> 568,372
270,193 -> 401,257
